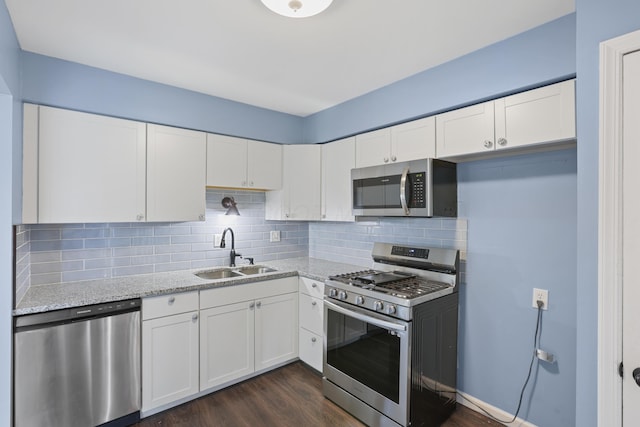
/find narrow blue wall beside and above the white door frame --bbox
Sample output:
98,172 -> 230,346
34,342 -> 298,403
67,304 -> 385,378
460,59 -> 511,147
576,0 -> 640,426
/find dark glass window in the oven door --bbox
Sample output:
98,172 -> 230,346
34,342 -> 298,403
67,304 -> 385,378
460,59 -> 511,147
327,310 -> 400,403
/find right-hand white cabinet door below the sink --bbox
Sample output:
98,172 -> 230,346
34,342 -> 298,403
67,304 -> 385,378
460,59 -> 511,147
255,292 -> 298,371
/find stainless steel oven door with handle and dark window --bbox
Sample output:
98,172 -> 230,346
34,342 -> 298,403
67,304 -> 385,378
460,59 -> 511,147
323,298 -> 411,425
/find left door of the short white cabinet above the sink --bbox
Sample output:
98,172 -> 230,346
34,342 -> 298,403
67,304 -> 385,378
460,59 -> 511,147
207,133 -> 247,187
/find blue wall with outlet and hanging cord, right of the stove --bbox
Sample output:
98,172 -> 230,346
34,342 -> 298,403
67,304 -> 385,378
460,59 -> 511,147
458,149 -> 577,427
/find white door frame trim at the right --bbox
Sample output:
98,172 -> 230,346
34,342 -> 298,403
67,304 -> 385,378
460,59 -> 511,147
598,31 -> 640,426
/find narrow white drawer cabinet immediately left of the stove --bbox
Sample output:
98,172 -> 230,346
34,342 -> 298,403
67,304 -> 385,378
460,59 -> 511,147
299,277 -> 324,372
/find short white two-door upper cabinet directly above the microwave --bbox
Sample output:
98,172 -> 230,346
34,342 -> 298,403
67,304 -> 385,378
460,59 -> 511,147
356,117 -> 435,168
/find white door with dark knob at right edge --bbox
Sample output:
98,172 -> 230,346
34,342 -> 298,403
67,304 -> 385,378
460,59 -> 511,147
622,52 -> 640,427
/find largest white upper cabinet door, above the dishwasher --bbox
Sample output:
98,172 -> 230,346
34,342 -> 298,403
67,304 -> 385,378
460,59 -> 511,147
36,107 -> 146,223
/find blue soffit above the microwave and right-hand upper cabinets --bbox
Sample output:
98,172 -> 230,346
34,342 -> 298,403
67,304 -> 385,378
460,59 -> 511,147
304,14 -> 576,142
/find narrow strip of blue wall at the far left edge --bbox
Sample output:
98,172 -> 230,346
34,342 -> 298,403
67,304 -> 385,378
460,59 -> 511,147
0,2 -> 22,426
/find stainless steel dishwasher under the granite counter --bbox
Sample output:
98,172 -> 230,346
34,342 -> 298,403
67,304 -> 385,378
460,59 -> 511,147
13,299 -> 141,427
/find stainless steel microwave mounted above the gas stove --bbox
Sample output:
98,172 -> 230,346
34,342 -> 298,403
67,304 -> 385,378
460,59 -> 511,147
351,159 -> 458,217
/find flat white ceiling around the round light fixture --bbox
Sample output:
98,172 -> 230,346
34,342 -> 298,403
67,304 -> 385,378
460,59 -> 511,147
5,0 -> 575,116
